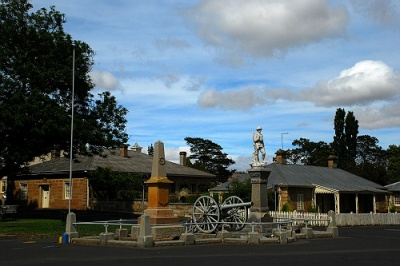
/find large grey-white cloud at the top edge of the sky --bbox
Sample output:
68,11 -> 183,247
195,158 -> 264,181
190,0 -> 348,60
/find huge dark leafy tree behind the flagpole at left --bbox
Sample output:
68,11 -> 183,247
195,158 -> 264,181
0,0 -> 127,176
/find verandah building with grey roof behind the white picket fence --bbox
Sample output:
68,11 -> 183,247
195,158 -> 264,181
210,150 -> 390,213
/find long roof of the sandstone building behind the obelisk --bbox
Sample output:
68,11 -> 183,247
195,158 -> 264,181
19,150 -> 215,178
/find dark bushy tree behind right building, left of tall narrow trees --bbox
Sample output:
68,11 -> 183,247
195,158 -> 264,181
287,138 -> 332,166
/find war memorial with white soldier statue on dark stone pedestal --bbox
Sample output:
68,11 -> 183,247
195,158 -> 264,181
247,127 -> 271,215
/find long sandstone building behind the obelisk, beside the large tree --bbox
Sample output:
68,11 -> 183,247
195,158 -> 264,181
13,144 -> 215,210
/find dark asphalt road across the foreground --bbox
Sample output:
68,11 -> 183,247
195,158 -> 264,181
0,226 -> 400,266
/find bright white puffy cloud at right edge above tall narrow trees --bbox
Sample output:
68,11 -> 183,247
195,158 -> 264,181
299,60 -> 400,106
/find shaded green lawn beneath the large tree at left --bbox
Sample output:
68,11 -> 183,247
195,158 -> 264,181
0,219 -> 128,238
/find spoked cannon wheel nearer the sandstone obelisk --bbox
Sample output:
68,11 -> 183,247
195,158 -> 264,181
192,196 -> 220,233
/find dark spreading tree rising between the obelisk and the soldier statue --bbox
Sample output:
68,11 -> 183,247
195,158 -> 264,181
185,137 -> 235,182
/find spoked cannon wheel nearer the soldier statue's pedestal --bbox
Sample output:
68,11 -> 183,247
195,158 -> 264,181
221,196 -> 248,231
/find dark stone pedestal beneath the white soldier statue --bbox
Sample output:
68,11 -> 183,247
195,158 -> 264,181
247,166 -> 272,213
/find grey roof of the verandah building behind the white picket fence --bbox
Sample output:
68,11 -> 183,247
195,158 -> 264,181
210,163 -> 388,193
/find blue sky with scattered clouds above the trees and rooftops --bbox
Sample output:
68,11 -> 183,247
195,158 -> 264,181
31,0 -> 400,171
